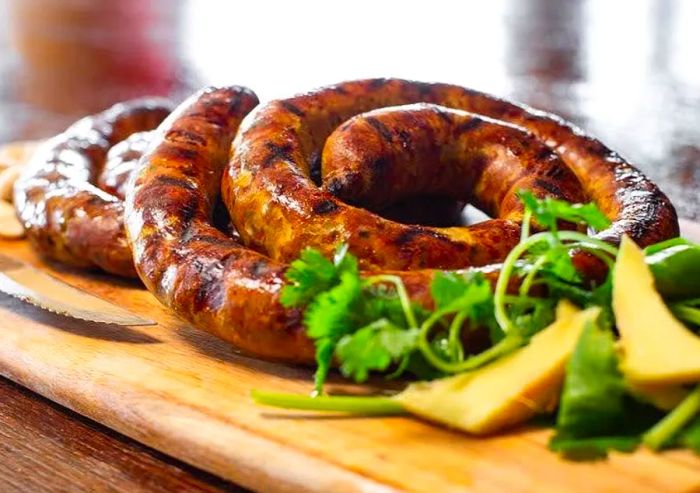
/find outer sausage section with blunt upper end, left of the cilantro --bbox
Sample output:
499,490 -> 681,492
125,87 -> 440,363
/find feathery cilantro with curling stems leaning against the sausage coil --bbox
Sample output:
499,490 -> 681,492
281,192 -> 615,393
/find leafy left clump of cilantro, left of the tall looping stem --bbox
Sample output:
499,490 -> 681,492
282,246 -> 508,394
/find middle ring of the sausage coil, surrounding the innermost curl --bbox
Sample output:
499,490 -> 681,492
222,79 -> 678,269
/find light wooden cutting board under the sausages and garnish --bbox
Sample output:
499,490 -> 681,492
0,223 -> 700,493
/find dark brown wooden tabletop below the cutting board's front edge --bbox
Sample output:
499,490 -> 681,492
0,379 -> 243,493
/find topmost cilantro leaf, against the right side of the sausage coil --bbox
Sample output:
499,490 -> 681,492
518,190 -> 610,231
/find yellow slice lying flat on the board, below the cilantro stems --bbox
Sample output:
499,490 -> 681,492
395,301 -> 600,435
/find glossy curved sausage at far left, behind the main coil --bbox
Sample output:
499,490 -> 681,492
14,98 -> 172,277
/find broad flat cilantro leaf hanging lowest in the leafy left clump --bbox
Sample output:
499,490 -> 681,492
336,319 -> 418,382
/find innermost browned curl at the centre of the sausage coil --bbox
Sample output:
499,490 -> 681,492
322,103 -> 584,221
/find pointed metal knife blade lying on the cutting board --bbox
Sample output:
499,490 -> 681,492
0,253 -> 156,325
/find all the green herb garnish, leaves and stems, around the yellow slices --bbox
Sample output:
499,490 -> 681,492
254,187 -> 700,459
